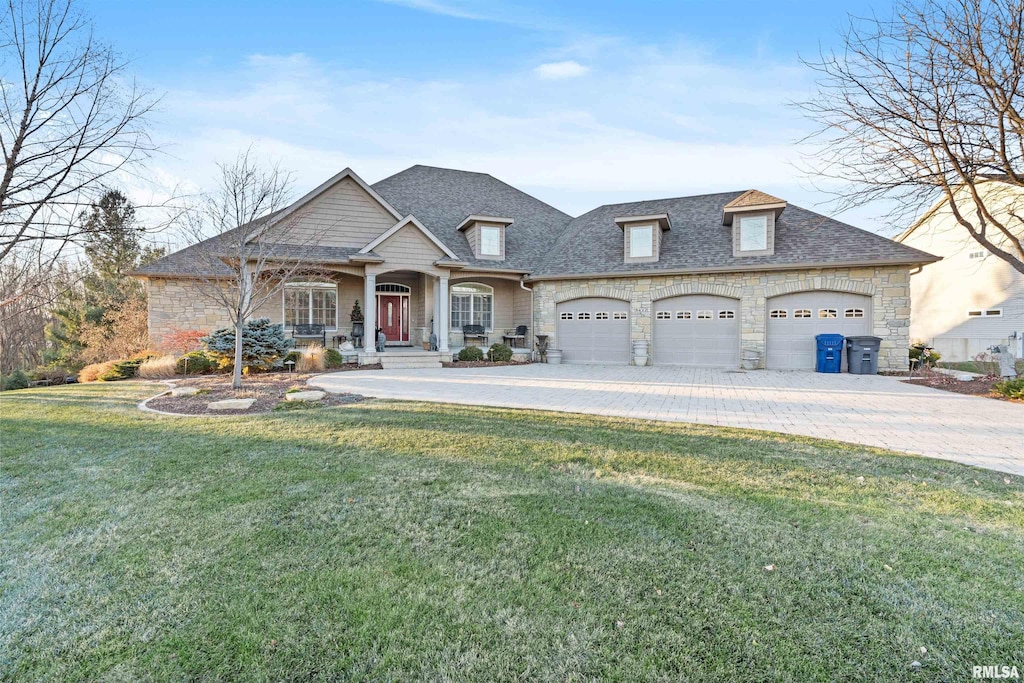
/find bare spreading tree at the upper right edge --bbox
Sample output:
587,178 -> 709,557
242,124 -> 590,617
801,0 -> 1024,273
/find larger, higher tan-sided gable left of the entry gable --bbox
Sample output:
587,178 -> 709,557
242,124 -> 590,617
261,177 -> 395,249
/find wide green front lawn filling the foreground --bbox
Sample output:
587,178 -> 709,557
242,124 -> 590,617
0,383 -> 1024,682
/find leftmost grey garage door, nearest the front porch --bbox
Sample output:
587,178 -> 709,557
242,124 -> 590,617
555,299 -> 630,365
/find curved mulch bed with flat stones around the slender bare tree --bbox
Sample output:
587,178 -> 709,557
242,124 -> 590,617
146,370 -> 366,415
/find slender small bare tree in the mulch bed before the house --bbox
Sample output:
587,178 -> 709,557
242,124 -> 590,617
186,151 -> 325,389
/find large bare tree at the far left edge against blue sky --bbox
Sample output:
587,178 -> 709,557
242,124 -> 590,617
0,0 -> 154,262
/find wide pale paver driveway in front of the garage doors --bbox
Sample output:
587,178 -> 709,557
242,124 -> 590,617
310,364 -> 1024,474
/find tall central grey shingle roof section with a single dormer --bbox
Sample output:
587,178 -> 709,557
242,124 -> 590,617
373,166 -> 572,270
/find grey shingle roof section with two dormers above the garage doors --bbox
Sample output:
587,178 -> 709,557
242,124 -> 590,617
532,191 -> 937,276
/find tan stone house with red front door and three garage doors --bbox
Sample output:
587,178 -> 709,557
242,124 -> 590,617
137,166 -> 936,370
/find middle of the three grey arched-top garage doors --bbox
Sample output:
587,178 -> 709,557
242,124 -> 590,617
653,294 -> 739,368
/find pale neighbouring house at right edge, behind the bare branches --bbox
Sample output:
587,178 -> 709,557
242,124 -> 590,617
896,182 -> 1024,361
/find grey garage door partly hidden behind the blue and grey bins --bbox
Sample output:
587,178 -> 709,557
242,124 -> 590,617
765,292 -> 871,372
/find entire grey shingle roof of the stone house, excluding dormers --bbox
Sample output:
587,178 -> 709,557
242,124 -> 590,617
137,166 -> 937,278
